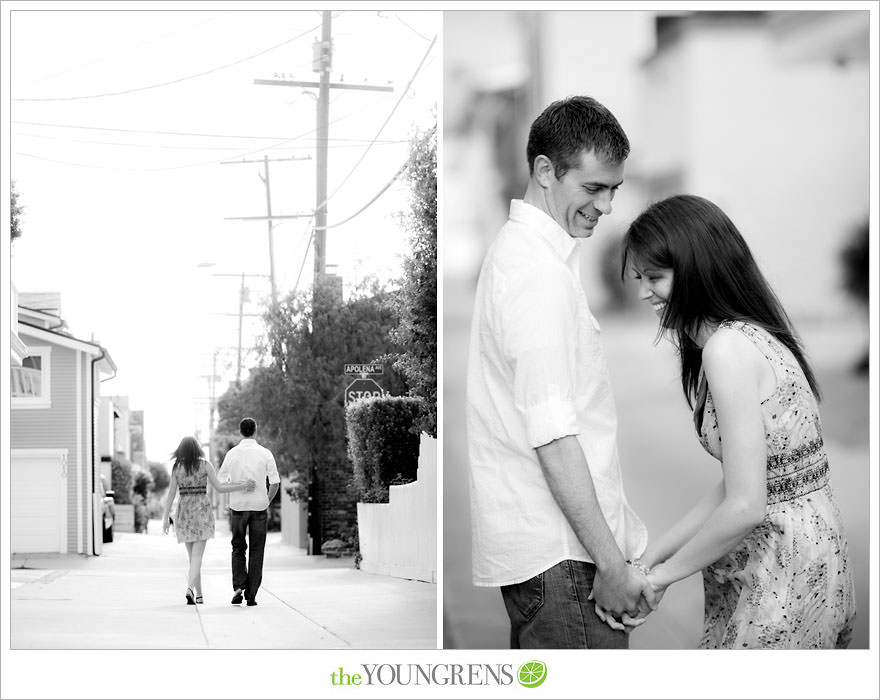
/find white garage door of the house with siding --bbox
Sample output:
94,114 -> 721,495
10,450 -> 67,554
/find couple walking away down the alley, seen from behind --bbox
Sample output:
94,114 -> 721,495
162,418 -> 281,606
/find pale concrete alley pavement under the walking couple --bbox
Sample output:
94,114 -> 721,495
10,520 -> 437,649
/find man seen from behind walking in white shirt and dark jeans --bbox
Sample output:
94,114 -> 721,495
218,418 -> 281,606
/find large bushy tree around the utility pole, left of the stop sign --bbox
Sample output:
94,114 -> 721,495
216,281 -> 408,551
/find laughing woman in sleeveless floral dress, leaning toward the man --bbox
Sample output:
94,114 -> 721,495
623,195 -> 855,649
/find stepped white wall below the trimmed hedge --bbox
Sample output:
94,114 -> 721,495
357,433 -> 437,583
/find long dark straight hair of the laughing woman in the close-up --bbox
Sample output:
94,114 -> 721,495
621,195 -> 820,408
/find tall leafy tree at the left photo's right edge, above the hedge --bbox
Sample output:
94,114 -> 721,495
390,126 -> 437,437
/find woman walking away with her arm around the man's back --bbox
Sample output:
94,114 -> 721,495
162,437 -> 256,605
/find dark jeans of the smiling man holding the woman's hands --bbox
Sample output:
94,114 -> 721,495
501,559 -> 629,649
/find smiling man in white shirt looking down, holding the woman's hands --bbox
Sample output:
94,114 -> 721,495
467,97 -> 655,648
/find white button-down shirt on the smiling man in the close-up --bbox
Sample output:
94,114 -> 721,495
467,200 -> 647,586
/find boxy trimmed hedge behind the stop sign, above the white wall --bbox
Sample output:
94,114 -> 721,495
345,396 -> 425,503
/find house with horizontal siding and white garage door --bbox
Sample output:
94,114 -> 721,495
9,293 -> 116,555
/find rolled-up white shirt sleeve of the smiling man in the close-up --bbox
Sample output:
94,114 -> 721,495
500,266 -> 578,448
